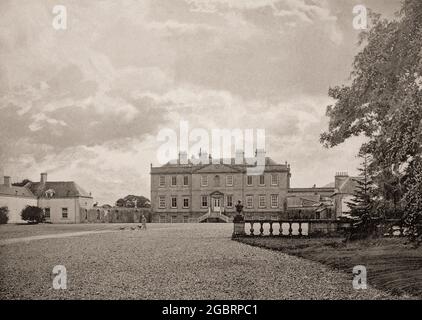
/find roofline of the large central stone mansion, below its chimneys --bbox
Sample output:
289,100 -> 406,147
151,157 -> 290,174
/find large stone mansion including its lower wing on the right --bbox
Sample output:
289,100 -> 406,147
151,153 -> 362,222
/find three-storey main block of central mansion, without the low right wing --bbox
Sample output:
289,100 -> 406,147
151,155 -> 290,223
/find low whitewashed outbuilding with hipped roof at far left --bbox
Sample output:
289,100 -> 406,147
0,173 -> 93,223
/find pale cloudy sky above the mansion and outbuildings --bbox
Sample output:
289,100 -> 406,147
0,0 -> 400,204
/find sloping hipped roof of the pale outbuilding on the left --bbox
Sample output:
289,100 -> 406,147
29,181 -> 92,198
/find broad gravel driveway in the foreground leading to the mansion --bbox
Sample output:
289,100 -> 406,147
0,224 -> 389,299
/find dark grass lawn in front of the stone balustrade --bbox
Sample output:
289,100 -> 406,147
237,237 -> 422,298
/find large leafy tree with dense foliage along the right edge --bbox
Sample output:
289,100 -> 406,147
321,0 -> 422,235
